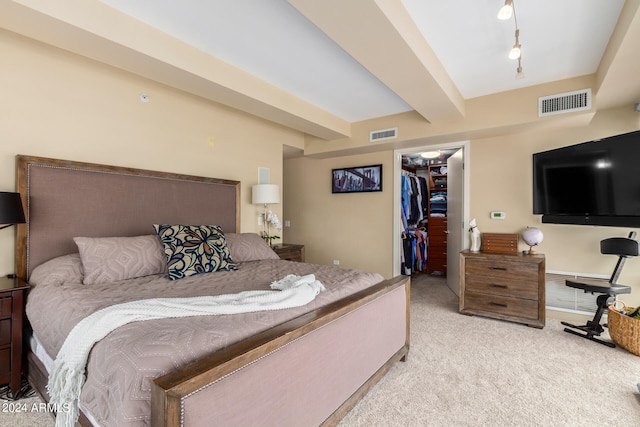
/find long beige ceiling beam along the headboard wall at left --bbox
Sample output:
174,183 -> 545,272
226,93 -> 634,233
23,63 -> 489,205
0,0 -> 351,140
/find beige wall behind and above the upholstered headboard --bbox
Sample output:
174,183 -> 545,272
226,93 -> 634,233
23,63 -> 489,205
0,30 -> 303,275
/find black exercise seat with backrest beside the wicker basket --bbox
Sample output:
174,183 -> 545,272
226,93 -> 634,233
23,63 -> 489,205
561,231 -> 640,347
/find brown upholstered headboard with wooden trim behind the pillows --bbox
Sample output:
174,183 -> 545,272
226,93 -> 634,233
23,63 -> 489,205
16,155 -> 240,279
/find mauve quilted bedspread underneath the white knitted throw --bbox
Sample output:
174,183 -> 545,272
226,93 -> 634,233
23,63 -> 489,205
26,255 -> 383,426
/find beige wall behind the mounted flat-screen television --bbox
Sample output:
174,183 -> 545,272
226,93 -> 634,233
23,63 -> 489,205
470,107 -> 640,284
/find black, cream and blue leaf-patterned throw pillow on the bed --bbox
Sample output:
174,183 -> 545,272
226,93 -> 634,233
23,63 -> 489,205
153,224 -> 238,280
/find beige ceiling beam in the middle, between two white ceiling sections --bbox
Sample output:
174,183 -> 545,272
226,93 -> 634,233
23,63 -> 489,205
289,0 -> 464,122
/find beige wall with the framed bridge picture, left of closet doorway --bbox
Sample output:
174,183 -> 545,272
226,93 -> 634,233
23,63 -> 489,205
283,152 -> 393,277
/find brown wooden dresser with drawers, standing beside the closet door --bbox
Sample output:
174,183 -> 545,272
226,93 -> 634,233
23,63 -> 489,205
460,251 -> 545,328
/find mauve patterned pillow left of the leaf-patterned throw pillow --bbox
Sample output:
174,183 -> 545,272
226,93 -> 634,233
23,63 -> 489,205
73,234 -> 167,285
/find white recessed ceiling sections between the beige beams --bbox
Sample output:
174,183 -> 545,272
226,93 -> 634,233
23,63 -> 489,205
101,0 -> 624,122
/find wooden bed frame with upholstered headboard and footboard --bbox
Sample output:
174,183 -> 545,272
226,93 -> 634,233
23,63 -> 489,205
16,155 -> 410,426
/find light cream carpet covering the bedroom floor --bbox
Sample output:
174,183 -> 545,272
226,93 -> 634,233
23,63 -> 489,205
6,276 -> 640,427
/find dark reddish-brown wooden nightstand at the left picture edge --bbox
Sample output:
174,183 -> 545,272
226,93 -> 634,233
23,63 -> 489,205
0,277 -> 29,396
